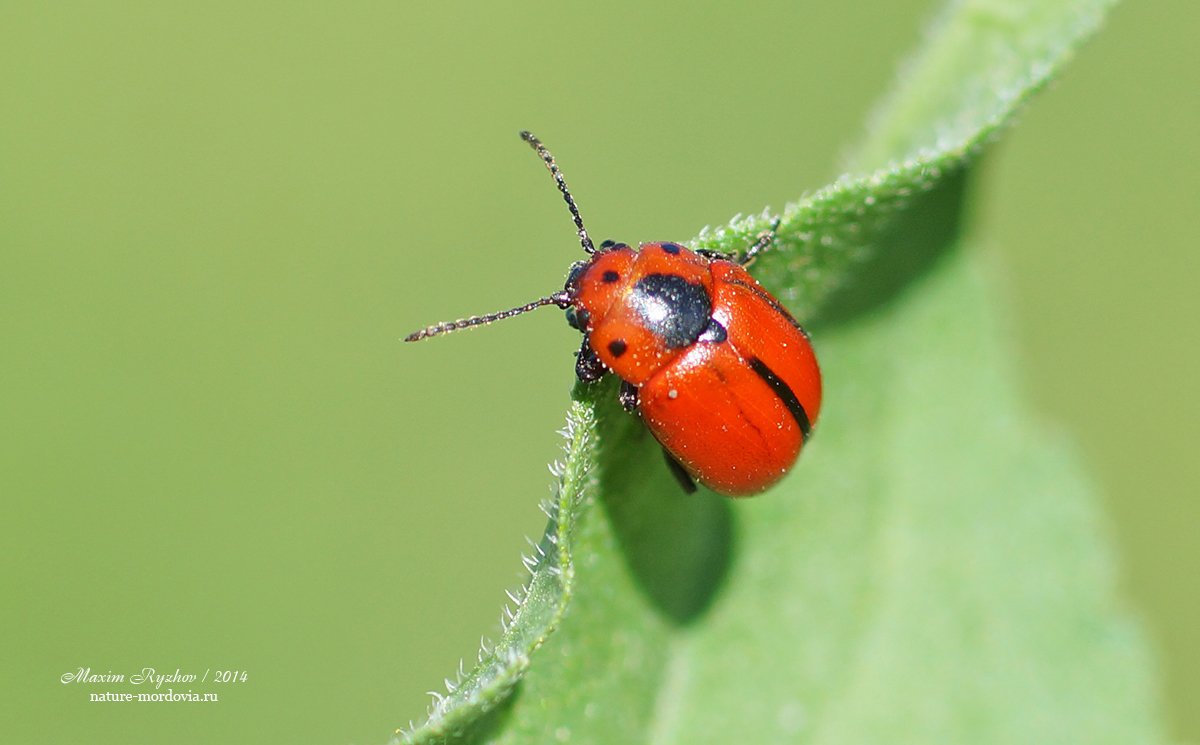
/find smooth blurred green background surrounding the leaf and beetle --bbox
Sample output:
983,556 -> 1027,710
0,0 -> 1200,744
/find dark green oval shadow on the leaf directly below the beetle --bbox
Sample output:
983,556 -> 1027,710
598,380 -> 734,626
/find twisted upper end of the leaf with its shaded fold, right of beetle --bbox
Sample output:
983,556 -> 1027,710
696,0 -> 1111,326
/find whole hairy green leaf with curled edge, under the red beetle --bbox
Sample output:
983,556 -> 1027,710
401,0 -> 1163,744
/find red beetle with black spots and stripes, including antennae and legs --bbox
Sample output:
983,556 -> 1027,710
404,132 -> 821,497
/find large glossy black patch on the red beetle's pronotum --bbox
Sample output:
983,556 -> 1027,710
629,275 -> 713,349
